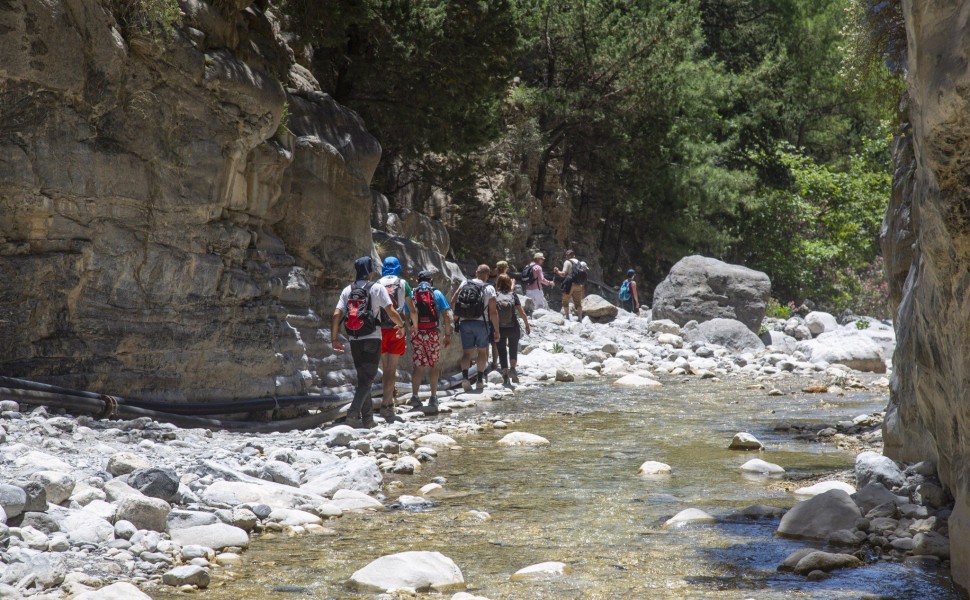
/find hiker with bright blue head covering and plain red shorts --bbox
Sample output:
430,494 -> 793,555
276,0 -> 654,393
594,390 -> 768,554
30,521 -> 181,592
378,256 -> 418,423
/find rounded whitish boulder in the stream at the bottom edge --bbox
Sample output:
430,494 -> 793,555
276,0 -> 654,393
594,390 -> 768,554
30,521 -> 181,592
347,551 -> 465,593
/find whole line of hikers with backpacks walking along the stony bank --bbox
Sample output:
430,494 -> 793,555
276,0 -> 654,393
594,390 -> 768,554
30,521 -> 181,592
330,250 -> 640,429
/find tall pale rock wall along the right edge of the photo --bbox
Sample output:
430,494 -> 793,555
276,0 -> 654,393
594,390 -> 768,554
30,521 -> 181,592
883,0 -> 970,589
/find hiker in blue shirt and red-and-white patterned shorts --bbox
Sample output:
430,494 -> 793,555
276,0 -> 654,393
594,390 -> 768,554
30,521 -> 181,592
409,271 -> 451,414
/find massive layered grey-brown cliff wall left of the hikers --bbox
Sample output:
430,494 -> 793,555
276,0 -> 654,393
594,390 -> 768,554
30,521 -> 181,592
0,0 -> 380,401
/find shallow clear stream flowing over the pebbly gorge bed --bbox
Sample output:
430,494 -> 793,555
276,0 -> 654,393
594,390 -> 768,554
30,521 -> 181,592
155,379 -> 959,600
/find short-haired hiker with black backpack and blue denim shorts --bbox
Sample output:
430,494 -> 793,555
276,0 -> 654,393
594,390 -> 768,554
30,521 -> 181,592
451,265 -> 499,392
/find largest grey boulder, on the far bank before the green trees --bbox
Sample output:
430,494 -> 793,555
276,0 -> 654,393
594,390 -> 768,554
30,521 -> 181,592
653,255 -> 771,332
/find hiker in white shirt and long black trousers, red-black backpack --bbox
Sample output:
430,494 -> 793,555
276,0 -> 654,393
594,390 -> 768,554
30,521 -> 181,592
330,256 -> 404,429
